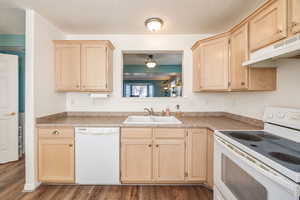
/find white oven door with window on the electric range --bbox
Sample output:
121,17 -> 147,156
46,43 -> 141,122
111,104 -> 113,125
214,136 -> 299,200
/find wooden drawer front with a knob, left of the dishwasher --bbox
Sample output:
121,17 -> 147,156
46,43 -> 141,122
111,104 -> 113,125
38,127 -> 74,138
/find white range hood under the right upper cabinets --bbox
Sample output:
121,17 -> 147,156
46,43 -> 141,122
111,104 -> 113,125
243,35 -> 300,67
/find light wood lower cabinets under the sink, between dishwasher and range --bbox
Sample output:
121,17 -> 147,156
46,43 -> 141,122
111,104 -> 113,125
121,128 -> 207,183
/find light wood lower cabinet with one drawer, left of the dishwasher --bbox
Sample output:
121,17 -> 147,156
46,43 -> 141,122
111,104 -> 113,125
38,128 -> 75,183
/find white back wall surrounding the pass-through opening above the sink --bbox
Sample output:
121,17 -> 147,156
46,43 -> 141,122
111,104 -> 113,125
67,35 -> 225,111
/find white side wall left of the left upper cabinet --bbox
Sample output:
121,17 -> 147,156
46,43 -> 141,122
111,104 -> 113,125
34,11 -> 66,117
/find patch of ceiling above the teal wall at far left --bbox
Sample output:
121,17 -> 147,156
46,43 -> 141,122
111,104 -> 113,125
0,7 -> 25,34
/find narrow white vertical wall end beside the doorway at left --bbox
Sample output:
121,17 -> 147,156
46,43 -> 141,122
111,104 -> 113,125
24,9 -> 39,191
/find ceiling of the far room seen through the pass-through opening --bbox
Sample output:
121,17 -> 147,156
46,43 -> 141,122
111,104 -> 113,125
123,52 -> 182,65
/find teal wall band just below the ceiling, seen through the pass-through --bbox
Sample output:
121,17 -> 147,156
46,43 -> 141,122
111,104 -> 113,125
123,65 -> 182,73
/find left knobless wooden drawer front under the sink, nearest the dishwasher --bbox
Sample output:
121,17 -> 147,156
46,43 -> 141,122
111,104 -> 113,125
121,128 -> 152,139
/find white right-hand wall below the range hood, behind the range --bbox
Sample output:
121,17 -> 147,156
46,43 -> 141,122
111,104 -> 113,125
226,59 -> 300,119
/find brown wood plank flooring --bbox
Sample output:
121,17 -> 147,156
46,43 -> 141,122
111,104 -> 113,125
0,160 -> 213,200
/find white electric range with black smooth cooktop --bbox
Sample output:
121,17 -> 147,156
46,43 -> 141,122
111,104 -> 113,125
214,107 -> 300,200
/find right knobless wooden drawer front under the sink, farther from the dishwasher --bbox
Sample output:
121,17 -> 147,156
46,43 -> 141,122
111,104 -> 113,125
154,128 -> 185,138
